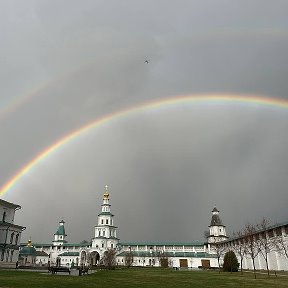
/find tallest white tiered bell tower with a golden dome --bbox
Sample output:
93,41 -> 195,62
92,185 -> 119,251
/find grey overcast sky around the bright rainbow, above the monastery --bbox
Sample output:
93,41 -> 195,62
0,0 -> 288,243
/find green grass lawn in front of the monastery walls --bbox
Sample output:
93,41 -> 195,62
0,268 -> 288,288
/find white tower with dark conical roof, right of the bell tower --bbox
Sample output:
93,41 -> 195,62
208,207 -> 228,243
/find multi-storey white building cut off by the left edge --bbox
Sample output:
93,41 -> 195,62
0,199 -> 25,267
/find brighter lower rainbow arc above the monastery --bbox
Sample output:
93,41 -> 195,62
0,94 -> 288,195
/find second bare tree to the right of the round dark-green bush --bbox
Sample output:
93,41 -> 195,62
243,223 -> 259,279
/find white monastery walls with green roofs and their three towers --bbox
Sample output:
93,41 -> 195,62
20,185 -> 288,270
